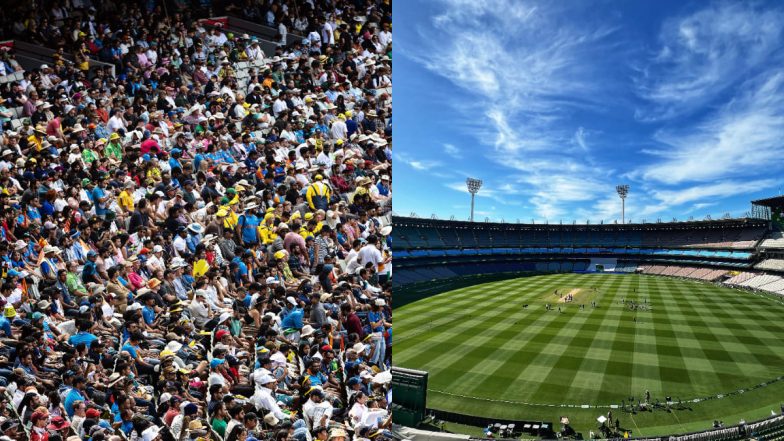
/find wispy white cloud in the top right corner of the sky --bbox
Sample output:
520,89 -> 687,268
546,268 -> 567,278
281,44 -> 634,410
636,2 -> 784,121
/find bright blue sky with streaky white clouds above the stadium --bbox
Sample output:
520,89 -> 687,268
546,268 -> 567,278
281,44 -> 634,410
394,0 -> 784,223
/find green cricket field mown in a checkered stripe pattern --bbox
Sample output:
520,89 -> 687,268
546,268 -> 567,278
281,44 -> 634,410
393,274 -> 784,436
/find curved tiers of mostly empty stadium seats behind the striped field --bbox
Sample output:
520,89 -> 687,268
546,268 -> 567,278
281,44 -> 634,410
393,217 -> 784,294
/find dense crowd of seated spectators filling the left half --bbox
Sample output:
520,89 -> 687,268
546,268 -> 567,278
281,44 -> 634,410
0,0 -> 392,441
